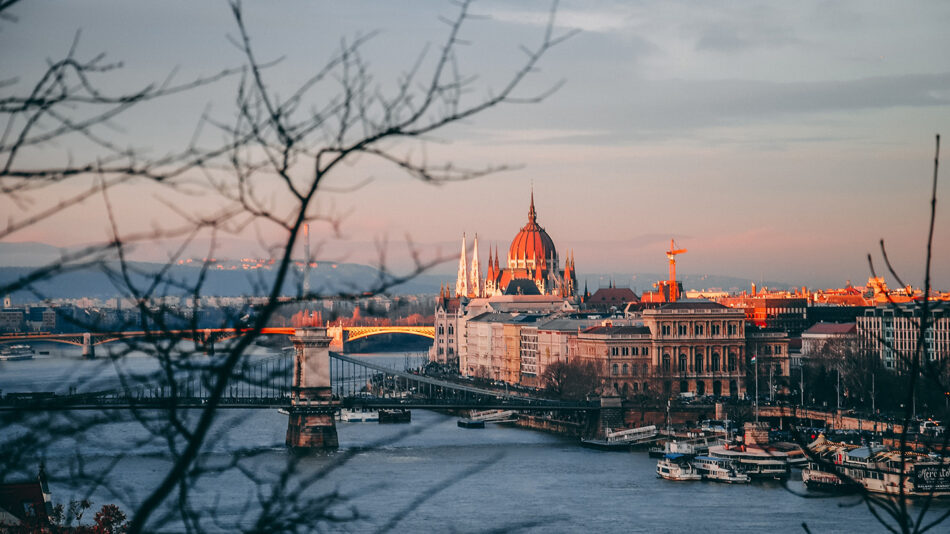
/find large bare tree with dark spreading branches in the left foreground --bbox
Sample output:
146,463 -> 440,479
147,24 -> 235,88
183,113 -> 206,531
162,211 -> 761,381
0,0 -> 570,532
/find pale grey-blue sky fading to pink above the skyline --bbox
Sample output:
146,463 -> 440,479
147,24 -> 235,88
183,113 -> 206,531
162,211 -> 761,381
0,0 -> 950,289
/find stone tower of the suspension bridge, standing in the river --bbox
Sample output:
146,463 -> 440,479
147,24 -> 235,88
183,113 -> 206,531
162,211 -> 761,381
286,327 -> 339,450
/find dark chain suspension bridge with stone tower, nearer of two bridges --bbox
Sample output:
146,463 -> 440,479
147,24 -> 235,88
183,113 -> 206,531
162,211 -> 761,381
0,327 -> 601,449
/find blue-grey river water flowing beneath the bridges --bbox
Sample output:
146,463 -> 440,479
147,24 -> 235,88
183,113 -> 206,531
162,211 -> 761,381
0,350 -> 940,533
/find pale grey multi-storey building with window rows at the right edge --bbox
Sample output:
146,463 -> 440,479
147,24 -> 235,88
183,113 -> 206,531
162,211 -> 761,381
856,301 -> 950,372
